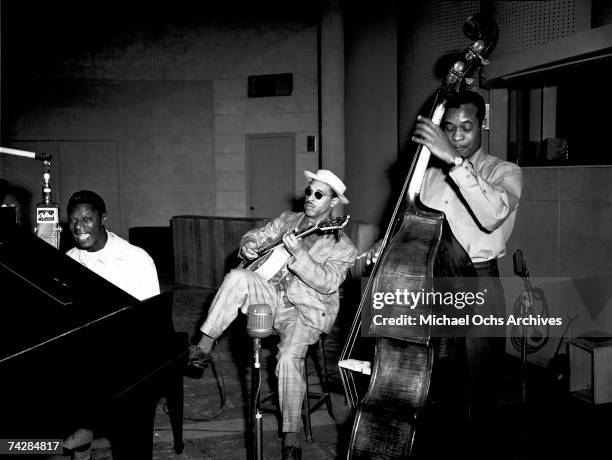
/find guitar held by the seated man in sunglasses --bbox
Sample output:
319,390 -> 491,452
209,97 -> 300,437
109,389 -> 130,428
238,215 -> 351,281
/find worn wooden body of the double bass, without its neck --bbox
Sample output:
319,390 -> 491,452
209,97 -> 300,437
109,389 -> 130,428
349,204 -> 475,459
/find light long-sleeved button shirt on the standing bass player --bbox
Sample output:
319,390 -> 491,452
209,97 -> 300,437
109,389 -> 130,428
420,148 -> 523,262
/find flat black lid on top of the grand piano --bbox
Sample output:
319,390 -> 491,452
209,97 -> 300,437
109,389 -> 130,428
0,224 -> 140,362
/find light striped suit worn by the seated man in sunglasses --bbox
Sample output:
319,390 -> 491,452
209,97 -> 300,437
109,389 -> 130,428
200,211 -> 357,432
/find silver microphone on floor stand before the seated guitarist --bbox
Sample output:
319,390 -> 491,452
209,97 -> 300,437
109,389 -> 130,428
247,303 -> 274,460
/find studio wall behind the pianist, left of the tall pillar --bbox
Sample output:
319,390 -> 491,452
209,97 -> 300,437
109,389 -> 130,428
1,2 -> 318,236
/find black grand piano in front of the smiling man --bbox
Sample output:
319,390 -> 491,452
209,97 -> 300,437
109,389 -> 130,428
0,222 -> 188,459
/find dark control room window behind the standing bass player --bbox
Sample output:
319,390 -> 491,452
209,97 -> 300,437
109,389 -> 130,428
508,58 -> 612,166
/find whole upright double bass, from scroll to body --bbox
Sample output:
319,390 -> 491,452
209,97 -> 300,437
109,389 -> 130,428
340,13 -> 498,459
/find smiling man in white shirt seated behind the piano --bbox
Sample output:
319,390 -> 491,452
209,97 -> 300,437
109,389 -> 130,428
64,190 -> 160,460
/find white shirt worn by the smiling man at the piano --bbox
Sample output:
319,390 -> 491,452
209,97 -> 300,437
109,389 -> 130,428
66,231 -> 160,300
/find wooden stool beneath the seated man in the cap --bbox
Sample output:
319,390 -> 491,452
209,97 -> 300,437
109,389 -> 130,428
260,334 -> 335,441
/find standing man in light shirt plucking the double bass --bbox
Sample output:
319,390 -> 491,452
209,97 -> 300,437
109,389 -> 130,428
368,90 -> 523,452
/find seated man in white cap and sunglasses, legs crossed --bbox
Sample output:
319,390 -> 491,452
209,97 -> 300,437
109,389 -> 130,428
190,169 -> 357,458
